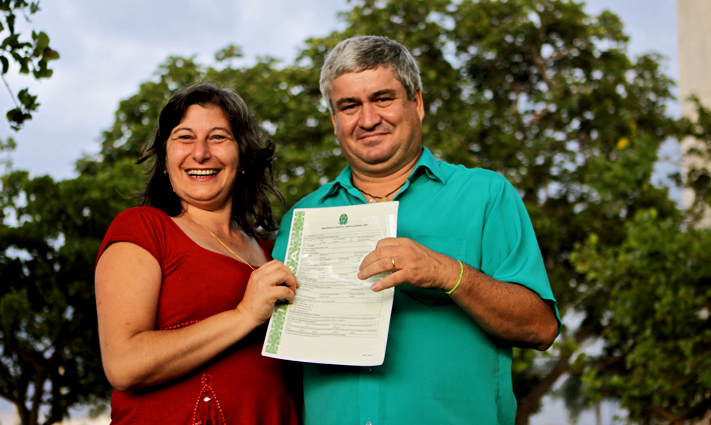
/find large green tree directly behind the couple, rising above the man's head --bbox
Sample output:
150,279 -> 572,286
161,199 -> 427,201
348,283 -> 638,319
80,0 -> 692,423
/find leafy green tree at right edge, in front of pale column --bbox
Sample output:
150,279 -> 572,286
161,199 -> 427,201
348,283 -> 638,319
571,103 -> 711,424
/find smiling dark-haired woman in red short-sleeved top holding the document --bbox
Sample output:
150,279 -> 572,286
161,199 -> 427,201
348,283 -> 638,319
96,83 -> 298,425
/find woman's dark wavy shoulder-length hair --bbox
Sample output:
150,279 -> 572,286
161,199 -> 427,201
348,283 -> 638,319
137,83 -> 284,237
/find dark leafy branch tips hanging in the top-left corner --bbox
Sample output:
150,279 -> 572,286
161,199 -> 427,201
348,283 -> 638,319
0,0 -> 59,130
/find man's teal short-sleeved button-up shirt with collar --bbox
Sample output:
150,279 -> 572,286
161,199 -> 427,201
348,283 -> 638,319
273,148 -> 560,425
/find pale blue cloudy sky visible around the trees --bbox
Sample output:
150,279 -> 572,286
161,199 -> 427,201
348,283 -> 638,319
0,0 -> 679,425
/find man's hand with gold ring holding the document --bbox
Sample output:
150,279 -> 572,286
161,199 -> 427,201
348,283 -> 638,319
358,238 -> 460,292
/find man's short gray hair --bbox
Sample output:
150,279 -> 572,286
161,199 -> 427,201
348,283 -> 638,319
319,35 -> 422,113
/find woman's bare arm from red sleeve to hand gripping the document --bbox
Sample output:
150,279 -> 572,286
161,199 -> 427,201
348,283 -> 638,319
96,242 -> 297,391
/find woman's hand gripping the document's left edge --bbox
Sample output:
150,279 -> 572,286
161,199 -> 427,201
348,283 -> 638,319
236,260 -> 299,326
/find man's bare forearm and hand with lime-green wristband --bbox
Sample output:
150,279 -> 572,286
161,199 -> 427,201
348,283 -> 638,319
358,238 -> 558,350
